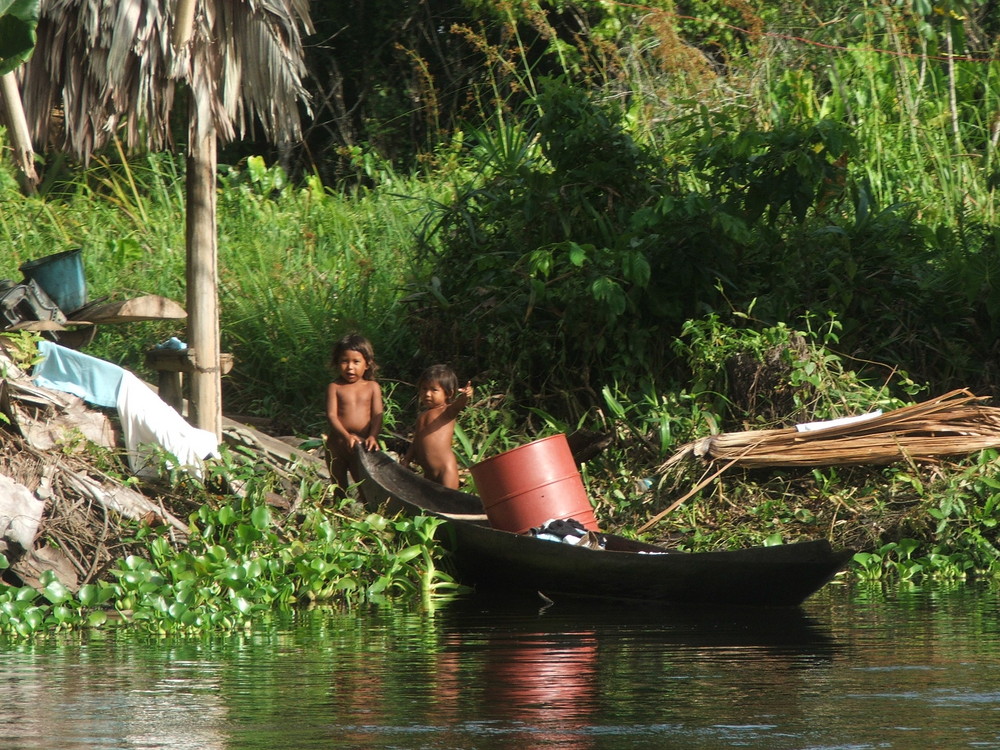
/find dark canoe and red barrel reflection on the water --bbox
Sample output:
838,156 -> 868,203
378,598 -> 836,748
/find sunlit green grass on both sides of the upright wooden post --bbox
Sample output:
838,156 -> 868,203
0,155 -> 458,434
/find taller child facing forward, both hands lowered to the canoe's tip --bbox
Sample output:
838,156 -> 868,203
326,333 -> 384,493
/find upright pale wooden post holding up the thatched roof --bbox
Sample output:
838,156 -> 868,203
187,96 -> 222,438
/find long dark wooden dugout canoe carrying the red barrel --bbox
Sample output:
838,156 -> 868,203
354,450 -> 854,607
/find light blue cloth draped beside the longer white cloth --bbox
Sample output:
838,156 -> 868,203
32,341 -> 125,408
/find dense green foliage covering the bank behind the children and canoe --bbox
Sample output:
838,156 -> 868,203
0,0 -> 1000,612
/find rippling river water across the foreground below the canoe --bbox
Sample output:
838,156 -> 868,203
0,583 -> 1000,750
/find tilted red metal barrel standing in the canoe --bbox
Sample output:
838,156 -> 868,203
470,434 -> 600,534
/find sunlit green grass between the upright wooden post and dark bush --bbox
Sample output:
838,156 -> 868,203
219,159 -> 446,425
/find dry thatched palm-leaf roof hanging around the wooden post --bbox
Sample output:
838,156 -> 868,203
22,0 -> 313,161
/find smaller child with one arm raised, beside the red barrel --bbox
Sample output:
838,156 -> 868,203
402,365 -> 472,490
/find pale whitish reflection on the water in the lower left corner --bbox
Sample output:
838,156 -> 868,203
0,635 -> 226,750
